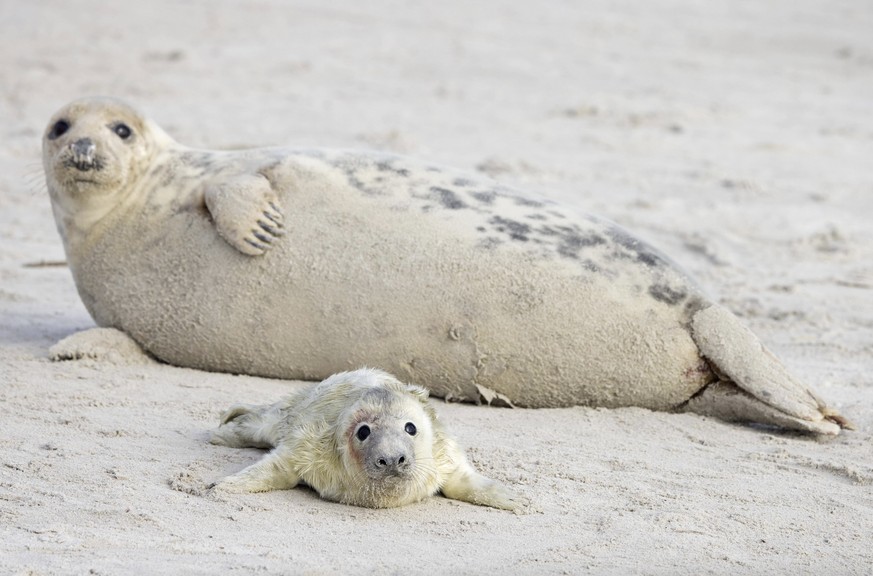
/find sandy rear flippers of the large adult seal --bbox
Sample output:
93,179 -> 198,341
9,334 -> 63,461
685,305 -> 854,434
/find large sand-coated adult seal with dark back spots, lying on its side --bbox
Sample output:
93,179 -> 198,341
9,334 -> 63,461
43,99 -> 848,434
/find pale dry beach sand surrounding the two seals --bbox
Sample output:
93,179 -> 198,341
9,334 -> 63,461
0,0 -> 873,575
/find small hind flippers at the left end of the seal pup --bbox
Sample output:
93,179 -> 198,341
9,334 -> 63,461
209,404 -> 282,448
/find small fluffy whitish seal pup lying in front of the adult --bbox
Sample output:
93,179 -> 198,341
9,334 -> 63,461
210,369 -> 519,510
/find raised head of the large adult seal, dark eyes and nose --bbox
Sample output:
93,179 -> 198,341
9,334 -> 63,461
42,98 -> 172,241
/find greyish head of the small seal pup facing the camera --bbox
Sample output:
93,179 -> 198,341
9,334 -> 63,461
336,383 -> 439,508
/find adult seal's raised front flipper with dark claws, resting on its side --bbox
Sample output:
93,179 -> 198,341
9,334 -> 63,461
204,175 -> 285,256
